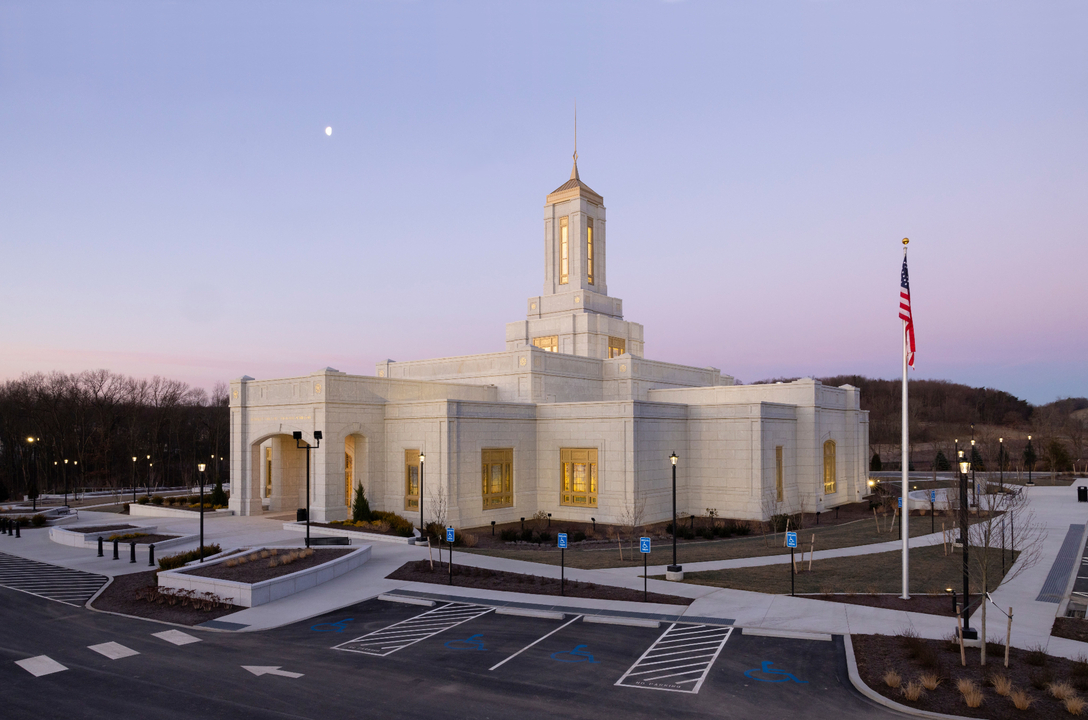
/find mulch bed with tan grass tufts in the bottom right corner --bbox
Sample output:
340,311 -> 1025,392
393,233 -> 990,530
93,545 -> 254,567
852,635 -> 1088,720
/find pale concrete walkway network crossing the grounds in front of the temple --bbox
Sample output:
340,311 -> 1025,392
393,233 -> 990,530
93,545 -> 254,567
0,487 -> 1088,657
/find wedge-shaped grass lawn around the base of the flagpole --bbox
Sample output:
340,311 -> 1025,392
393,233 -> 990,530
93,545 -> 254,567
683,545 -> 1014,595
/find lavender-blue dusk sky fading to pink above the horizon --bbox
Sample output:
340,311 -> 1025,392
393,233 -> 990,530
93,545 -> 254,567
0,0 -> 1088,404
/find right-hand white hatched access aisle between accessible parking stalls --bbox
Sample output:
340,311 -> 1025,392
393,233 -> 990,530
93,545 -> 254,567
616,623 -> 733,694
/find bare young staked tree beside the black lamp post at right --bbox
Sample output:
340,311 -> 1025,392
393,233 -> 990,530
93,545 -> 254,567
965,485 -> 1047,666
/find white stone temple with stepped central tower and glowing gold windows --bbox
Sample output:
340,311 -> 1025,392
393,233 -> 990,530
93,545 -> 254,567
231,156 -> 868,527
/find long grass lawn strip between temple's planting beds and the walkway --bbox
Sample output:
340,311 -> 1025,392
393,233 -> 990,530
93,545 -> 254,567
462,516 -> 975,574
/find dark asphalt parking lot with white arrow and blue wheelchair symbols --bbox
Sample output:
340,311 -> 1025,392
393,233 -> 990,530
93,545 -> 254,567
0,588 -> 899,720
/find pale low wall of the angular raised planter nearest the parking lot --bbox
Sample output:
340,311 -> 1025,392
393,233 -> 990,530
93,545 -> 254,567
159,545 -> 370,608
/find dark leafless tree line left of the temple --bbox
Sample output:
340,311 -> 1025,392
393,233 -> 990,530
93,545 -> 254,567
0,370 -> 230,500
